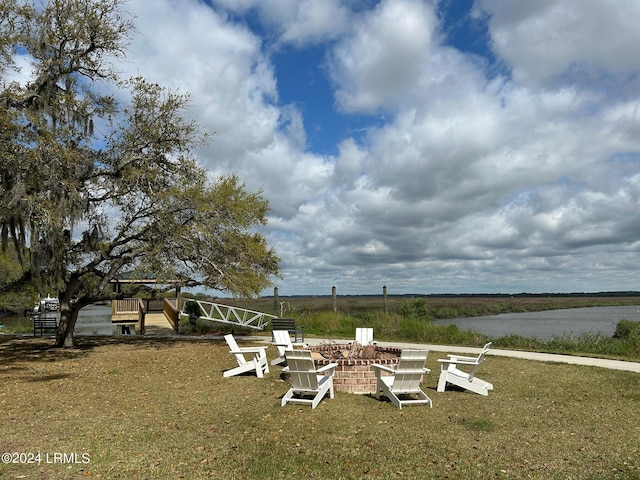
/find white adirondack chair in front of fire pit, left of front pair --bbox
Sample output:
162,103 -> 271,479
282,350 -> 338,408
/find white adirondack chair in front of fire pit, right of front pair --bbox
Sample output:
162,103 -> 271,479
371,350 -> 433,409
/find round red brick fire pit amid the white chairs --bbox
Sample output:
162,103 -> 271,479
309,342 -> 401,393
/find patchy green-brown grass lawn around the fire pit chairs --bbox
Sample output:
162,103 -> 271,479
0,337 -> 640,480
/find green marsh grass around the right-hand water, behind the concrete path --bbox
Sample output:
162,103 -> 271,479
219,295 -> 640,360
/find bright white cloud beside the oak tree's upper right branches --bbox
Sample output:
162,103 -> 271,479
125,0 -> 281,170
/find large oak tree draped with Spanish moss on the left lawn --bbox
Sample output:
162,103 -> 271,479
0,0 -> 278,346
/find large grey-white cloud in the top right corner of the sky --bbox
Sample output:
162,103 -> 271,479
477,0 -> 640,92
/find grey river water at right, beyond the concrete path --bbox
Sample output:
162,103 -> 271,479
435,305 -> 640,341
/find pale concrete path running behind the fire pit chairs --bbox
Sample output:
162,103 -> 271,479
250,337 -> 640,373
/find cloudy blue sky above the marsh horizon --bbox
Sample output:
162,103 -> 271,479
47,0 -> 640,295
